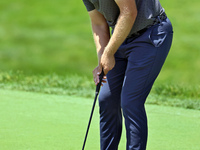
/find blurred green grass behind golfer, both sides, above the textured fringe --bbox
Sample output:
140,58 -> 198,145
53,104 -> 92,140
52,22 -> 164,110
0,0 -> 200,85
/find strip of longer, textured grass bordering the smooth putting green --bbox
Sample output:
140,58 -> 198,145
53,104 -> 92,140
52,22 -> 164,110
0,71 -> 200,110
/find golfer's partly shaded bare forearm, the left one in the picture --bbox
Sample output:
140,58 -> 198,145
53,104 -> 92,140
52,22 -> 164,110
92,23 -> 110,64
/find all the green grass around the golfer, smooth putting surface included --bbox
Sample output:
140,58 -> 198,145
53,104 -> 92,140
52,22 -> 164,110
0,0 -> 200,150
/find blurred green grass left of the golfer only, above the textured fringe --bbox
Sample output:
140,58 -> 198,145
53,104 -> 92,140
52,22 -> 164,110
0,0 -> 96,73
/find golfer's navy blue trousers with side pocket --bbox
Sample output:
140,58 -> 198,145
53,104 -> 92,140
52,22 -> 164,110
99,19 -> 173,150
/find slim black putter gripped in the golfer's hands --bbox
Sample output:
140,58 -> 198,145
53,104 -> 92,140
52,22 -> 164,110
82,70 -> 104,150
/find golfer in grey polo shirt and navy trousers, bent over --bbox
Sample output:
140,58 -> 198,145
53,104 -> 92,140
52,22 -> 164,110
83,0 -> 173,150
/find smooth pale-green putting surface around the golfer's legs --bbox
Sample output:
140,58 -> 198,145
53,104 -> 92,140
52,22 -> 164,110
0,90 -> 200,150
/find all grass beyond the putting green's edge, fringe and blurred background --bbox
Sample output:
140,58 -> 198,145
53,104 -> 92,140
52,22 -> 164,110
0,0 -> 200,109
